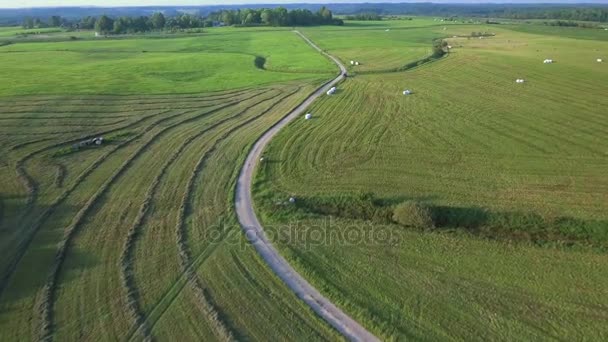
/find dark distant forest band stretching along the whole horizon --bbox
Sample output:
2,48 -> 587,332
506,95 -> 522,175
0,3 -> 608,27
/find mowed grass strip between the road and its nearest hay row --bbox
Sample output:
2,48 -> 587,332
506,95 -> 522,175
173,83 -> 339,340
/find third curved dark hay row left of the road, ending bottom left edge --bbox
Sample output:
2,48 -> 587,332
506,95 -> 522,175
38,93 -> 268,341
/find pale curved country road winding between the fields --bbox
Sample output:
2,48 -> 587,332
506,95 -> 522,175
235,31 -> 378,341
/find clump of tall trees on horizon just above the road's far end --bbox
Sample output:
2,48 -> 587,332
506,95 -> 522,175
207,6 -> 344,26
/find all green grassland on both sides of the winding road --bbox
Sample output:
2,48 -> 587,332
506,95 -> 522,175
0,18 -> 608,341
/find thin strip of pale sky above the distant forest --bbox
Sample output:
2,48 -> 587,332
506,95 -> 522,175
0,0 -> 608,8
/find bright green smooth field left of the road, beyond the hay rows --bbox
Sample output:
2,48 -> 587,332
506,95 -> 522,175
0,30 -> 334,95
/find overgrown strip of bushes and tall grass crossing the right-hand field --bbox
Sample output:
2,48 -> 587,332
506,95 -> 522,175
258,193 -> 608,251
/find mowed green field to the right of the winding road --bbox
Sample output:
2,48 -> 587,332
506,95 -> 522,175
254,25 -> 608,340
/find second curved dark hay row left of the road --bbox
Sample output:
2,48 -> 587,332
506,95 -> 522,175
120,87 -> 293,341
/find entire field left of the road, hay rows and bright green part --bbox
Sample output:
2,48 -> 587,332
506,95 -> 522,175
0,31 -> 338,341
